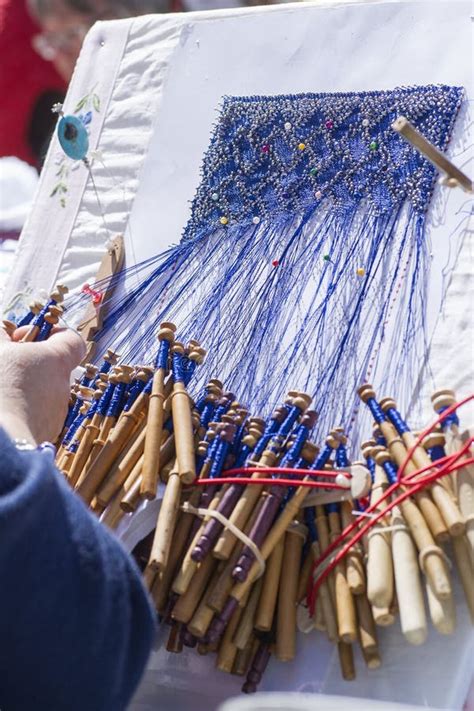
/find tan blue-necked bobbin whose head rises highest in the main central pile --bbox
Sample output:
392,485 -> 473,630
140,322 -> 176,499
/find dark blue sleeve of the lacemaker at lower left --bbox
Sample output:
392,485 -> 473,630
0,430 -> 155,711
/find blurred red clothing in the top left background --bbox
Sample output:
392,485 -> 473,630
0,0 -> 66,166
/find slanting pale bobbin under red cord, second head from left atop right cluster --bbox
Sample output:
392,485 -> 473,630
379,398 -> 466,536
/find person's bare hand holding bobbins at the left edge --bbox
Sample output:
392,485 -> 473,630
0,328 -> 86,443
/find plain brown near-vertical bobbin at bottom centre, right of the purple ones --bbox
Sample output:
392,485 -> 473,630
275,522 -> 307,662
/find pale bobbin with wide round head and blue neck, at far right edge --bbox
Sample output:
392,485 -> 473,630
431,390 -> 474,566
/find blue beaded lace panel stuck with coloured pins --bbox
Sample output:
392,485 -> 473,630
184,86 -> 463,239
